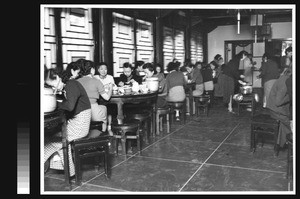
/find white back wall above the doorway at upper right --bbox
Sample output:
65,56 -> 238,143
207,22 -> 292,62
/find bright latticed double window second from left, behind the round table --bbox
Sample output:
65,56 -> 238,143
113,12 -> 154,77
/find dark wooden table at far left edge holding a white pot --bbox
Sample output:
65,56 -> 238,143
44,109 -> 71,189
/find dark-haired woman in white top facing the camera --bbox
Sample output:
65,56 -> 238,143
94,62 -> 117,136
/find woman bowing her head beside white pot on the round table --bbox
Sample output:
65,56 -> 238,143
144,63 -> 167,108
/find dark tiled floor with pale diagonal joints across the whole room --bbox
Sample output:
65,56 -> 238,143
44,100 -> 293,194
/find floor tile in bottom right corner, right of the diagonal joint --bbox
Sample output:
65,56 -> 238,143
182,164 -> 287,193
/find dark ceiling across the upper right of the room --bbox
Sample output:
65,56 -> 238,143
112,8 -> 292,32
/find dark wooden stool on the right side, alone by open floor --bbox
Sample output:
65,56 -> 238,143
250,114 -> 279,156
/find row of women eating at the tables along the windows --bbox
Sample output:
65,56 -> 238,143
44,46 -> 288,176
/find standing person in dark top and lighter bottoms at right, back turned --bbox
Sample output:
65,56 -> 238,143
258,53 -> 279,108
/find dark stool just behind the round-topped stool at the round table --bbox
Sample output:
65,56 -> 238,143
126,110 -> 154,143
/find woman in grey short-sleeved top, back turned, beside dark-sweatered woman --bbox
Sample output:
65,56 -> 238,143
76,59 -> 113,132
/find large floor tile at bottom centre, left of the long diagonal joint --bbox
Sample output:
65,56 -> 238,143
88,157 -> 199,192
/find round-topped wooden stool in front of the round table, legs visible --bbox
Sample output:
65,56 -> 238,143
111,119 -> 142,159
